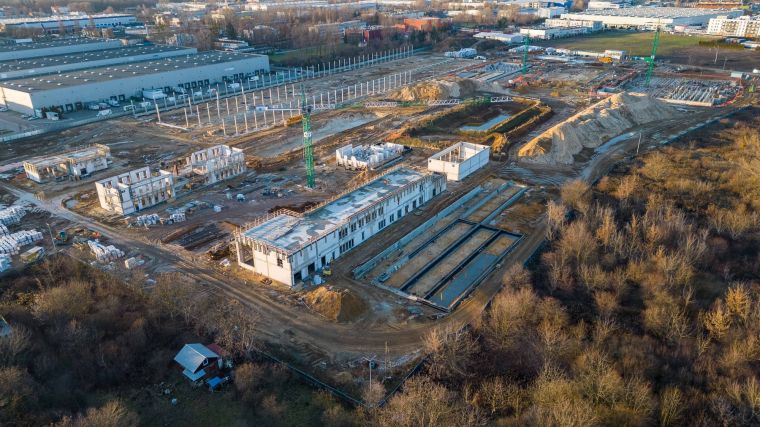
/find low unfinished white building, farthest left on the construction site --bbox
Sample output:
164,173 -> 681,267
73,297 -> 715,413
24,144 -> 111,183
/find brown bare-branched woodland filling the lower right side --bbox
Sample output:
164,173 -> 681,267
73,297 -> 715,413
375,115 -> 760,426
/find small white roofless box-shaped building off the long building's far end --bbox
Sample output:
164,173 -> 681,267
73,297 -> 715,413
428,142 -> 491,181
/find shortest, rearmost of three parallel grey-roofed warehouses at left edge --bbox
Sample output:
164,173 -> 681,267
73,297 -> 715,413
0,38 -> 122,61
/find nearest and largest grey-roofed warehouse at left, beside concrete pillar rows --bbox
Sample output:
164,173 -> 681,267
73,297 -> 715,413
0,51 -> 269,116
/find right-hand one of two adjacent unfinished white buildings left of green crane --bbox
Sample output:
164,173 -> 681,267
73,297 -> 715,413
186,145 -> 245,184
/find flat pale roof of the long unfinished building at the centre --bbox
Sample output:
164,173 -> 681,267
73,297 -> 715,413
243,168 -> 427,253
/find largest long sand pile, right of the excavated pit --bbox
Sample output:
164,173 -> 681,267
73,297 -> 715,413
518,93 -> 678,165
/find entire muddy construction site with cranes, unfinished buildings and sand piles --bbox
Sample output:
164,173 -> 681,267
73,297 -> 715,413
0,31 -> 754,402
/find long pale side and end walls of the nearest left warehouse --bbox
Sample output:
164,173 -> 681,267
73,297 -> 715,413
0,55 -> 269,114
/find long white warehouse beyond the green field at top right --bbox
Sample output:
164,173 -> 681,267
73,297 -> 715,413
562,7 -> 743,29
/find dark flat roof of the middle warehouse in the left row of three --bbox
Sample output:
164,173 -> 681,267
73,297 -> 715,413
0,45 -> 195,74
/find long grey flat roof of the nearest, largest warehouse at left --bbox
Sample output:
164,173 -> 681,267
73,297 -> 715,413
0,50 -> 265,92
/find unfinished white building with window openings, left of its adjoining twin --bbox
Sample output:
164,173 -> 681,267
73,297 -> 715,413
95,166 -> 176,215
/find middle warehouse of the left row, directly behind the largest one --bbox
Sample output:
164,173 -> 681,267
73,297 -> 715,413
0,45 -> 198,80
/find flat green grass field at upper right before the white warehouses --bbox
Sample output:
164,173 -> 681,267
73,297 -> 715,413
537,31 -> 719,56
